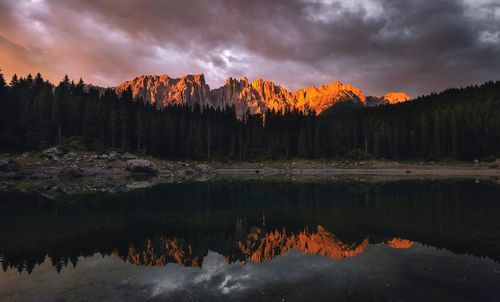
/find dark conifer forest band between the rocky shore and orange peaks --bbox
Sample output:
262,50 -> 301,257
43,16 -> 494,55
0,74 -> 500,160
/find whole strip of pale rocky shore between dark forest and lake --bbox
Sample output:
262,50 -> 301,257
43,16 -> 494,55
0,147 -> 500,198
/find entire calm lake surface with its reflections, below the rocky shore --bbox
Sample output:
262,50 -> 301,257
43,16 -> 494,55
0,180 -> 500,301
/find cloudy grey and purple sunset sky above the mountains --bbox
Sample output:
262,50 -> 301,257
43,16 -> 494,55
0,0 -> 500,97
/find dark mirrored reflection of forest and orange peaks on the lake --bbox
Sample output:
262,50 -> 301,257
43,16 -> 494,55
0,180 -> 500,272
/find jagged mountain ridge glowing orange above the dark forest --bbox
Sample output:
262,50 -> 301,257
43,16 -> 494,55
115,74 -> 410,116
